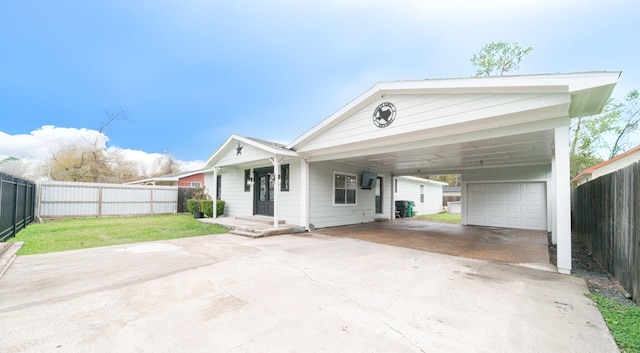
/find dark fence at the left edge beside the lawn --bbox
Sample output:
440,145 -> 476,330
0,173 -> 36,241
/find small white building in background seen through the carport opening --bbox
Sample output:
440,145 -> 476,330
393,176 -> 447,215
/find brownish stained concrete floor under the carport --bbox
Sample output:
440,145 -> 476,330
316,218 -> 556,271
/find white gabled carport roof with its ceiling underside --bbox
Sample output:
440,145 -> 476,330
286,71 -> 620,175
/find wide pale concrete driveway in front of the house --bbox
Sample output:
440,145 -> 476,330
0,234 -> 618,352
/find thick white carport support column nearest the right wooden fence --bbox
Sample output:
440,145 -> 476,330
554,125 -> 571,275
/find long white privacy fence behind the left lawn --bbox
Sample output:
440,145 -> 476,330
36,181 -> 178,218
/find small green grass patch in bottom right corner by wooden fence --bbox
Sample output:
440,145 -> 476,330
588,294 -> 640,353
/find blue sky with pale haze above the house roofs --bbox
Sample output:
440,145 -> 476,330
0,0 -> 640,161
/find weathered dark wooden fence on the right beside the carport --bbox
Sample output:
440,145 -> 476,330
571,163 -> 640,303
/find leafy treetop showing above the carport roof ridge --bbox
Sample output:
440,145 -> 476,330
471,42 -> 533,77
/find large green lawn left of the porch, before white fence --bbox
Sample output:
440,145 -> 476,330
9,214 -> 227,255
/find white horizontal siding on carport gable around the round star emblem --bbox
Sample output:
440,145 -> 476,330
299,93 -> 568,152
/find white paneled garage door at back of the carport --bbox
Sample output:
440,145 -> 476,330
467,183 -> 547,230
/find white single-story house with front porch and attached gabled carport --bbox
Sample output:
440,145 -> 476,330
205,72 -> 620,273
